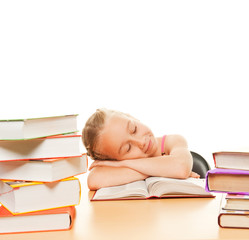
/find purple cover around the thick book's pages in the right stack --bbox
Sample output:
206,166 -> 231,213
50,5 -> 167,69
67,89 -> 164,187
205,168 -> 249,195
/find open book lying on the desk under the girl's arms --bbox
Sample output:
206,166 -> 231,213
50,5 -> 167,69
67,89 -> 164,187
91,177 -> 214,201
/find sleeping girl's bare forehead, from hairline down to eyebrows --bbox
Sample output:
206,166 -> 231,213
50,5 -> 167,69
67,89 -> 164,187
97,114 -> 132,159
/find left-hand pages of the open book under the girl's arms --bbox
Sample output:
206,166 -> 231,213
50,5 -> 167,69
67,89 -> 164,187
93,181 -> 149,200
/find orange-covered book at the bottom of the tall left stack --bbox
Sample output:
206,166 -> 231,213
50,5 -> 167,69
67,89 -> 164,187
0,206 -> 75,234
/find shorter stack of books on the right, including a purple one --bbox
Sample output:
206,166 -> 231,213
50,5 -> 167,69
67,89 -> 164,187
206,152 -> 249,228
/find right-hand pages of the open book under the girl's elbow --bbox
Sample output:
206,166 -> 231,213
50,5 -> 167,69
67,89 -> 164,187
146,177 -> 211,197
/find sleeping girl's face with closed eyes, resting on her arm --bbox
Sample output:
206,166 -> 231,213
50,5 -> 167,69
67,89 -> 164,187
96,113 -> 158,160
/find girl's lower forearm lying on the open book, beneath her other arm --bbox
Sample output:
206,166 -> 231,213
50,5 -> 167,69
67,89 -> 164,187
87,166 -> 148,190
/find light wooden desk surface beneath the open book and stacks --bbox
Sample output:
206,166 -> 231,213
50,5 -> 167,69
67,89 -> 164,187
0,174 -> 249,240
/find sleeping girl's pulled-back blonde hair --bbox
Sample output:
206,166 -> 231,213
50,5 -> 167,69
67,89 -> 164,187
82,108 -> 116,160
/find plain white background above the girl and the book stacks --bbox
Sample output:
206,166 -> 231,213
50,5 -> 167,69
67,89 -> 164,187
0,0 -> 249,167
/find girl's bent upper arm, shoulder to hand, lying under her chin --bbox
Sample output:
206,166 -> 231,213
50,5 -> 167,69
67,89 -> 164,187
91,135 -> 193,178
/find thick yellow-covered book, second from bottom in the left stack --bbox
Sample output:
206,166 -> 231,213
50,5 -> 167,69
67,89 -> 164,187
0,177 -> 81,215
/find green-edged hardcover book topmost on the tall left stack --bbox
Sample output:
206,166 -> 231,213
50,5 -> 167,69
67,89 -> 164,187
0,114 -> 78,140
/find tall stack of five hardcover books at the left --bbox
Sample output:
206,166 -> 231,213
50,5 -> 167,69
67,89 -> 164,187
0,115 -> 87,234
